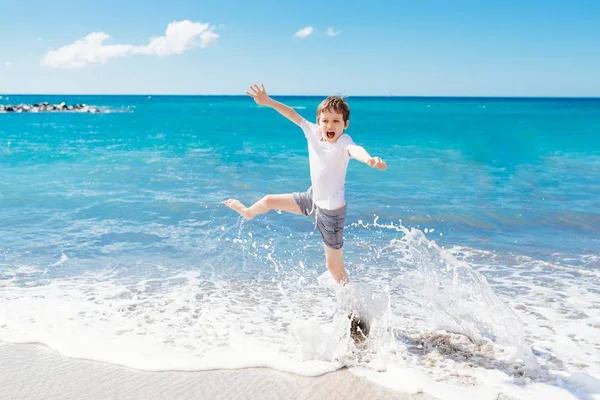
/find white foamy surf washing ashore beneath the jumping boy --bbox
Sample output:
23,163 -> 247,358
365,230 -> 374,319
0,220 -> 600,399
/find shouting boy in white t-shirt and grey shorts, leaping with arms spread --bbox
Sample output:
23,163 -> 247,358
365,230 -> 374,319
224,85 -> 387,285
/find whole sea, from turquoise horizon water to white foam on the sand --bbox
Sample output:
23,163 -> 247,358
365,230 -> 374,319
0,94 -> 600,399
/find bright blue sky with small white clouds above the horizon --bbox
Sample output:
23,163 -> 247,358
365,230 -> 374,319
0,0 -> 600,97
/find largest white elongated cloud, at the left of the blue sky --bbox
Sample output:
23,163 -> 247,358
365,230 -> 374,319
42,20 -> 219,68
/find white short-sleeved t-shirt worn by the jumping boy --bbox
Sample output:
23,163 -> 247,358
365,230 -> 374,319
300,119 -> 354,210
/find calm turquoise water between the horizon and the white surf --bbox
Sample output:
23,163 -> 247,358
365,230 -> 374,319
0,96 -> 600,261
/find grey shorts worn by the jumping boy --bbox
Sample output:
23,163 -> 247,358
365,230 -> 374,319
293,188 -> 346,249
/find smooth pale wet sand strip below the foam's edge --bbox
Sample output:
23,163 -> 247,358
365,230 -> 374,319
0,343 -> 433,400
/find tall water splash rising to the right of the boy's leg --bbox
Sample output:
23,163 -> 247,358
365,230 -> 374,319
388,227 -> 532,362
